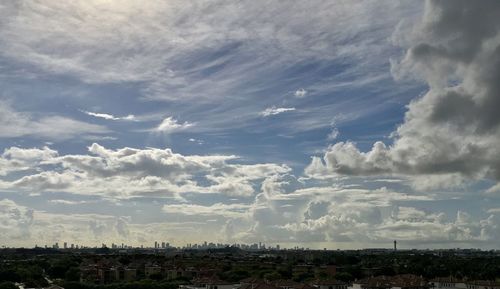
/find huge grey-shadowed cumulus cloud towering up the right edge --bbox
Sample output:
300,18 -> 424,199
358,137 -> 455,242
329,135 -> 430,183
306,1 -> 500,187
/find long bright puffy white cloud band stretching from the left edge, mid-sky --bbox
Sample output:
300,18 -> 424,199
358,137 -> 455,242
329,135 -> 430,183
0,143 -> 290,198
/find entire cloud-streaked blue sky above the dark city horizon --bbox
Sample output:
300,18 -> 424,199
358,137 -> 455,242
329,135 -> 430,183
0,0 -> 500,249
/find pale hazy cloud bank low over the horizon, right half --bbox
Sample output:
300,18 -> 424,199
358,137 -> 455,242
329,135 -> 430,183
224,180 -> 500,248
